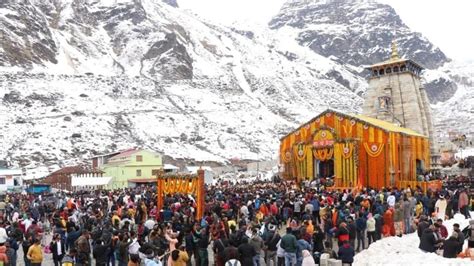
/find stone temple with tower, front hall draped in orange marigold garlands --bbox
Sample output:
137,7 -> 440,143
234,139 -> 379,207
280,44 -> 434,188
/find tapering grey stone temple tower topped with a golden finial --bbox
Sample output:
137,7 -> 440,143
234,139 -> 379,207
363,43 -> 439,167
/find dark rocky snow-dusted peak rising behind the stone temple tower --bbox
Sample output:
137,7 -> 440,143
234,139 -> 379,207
269,0 -> 474,141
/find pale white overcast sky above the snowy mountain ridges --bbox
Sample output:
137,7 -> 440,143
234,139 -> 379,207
178,0 -> 474,61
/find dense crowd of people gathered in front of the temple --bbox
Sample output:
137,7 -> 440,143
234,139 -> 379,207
0,178 -> 474,266
